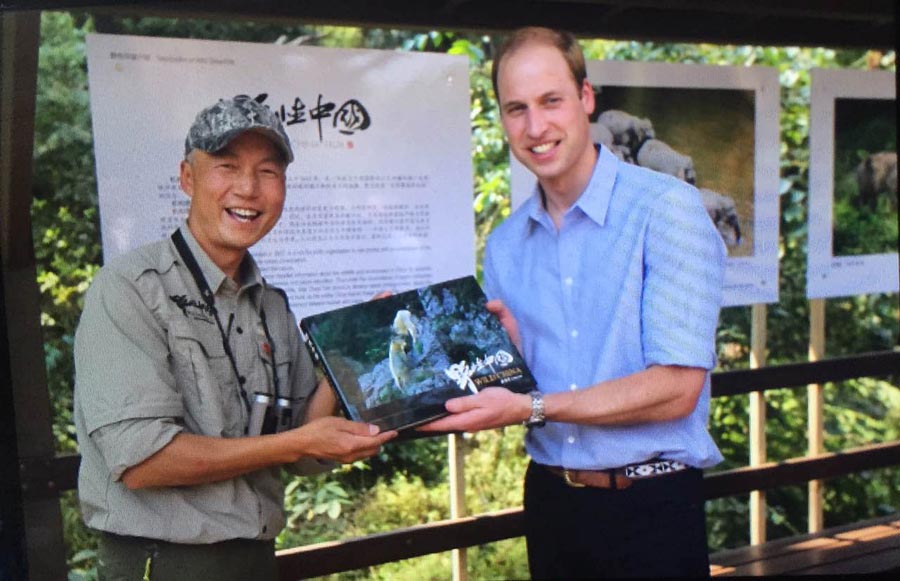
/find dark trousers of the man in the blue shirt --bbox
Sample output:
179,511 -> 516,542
525,462 -> 709,579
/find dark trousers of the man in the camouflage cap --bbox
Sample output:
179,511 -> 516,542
97,533 -> 277,581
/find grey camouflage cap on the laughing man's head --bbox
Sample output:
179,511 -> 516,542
184,95 -> 294,163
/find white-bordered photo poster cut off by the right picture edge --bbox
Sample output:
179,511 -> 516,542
806,69 -> 900,298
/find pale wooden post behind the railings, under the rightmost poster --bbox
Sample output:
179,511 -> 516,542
806,299 -> 825,533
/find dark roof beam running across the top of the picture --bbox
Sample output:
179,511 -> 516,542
5,0 -> 896,49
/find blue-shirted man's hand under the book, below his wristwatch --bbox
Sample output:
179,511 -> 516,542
417,387 -> 531,432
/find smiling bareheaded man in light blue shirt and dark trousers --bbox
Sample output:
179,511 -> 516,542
425,28 -> 725,579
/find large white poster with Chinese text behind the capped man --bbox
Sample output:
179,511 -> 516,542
87,34 -> 475,317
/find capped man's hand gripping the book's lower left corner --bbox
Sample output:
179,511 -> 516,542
283,416 -> 397,463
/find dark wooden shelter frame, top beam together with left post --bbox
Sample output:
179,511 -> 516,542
0,0 -> 896,579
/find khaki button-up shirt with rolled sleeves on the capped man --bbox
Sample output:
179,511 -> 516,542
75,225 -> 323,543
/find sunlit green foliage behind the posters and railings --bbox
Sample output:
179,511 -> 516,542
26,12 -> 900,580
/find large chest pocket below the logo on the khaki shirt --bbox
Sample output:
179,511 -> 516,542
169,320 -> 244,437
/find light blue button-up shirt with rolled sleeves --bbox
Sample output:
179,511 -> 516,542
484,148 -> 725,470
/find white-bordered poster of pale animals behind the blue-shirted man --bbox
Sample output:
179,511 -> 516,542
510,61 -> 780,306
